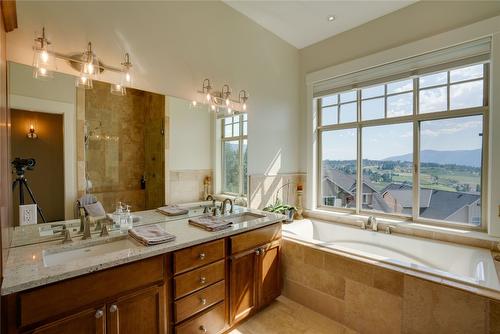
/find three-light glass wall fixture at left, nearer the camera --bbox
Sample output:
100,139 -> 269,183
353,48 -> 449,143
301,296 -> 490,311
33,27 -> 132,95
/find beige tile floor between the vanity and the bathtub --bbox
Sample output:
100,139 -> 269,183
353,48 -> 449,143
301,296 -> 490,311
229,296 -> 356,334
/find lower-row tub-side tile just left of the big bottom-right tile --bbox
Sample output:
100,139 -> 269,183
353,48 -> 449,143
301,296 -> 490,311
345,280 -> 403,334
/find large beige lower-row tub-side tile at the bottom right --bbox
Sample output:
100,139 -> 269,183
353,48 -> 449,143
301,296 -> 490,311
403,275 -> 487,334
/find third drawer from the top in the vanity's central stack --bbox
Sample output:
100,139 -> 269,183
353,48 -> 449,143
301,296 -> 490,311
174,281 -> 226,323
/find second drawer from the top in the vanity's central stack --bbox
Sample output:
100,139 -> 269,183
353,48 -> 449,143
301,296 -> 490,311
174,260 -> 225,299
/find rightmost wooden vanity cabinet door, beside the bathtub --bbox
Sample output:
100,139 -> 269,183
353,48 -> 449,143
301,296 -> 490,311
257,241 -> 281,308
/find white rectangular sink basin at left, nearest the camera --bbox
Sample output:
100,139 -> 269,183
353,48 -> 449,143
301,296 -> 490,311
43,239 -> 136,267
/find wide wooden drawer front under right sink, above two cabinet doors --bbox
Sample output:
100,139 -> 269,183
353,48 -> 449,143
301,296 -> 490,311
231,223 -> 281,254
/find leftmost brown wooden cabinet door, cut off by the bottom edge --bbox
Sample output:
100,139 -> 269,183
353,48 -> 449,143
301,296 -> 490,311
34,305 -> 106,334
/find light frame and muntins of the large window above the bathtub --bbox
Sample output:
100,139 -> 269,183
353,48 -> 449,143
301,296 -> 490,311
314,61 -> 490,230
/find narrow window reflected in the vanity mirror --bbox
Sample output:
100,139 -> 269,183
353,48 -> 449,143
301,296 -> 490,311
221,114 -> 248,195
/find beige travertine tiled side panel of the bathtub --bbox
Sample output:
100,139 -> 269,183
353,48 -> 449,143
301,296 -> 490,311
282,237 -> 500,334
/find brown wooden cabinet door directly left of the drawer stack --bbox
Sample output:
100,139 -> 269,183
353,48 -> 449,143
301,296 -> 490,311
107,286 -> 166,334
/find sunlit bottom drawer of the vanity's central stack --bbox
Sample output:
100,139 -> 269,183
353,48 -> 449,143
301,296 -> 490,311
175,302 -> 226,334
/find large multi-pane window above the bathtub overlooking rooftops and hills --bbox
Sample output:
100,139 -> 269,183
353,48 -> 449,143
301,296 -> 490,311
317,64 -> 488,227
